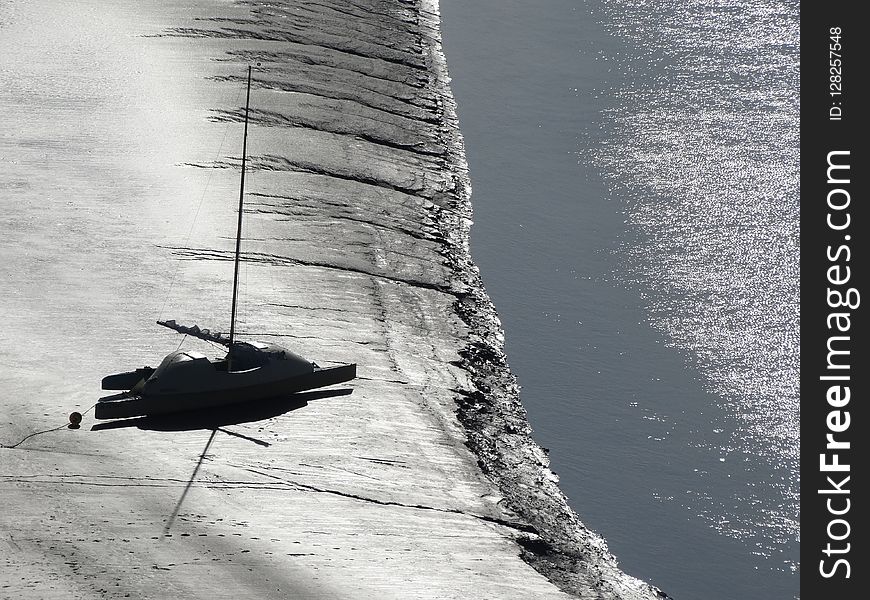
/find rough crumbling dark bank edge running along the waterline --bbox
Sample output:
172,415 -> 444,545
420,0 -> 669,599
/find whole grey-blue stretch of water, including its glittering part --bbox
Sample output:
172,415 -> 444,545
441,0 -> 799,600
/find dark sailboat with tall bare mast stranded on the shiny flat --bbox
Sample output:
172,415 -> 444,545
94,66 -> 356,419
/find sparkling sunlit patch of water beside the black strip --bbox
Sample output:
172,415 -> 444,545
594,0 -> 800,571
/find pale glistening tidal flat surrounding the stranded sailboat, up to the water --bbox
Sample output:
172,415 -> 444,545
0,0 -> 657,599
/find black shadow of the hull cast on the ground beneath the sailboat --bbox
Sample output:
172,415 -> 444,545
91,388 -> 353,446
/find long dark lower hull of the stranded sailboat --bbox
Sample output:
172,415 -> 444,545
94,364 -> 356,419
